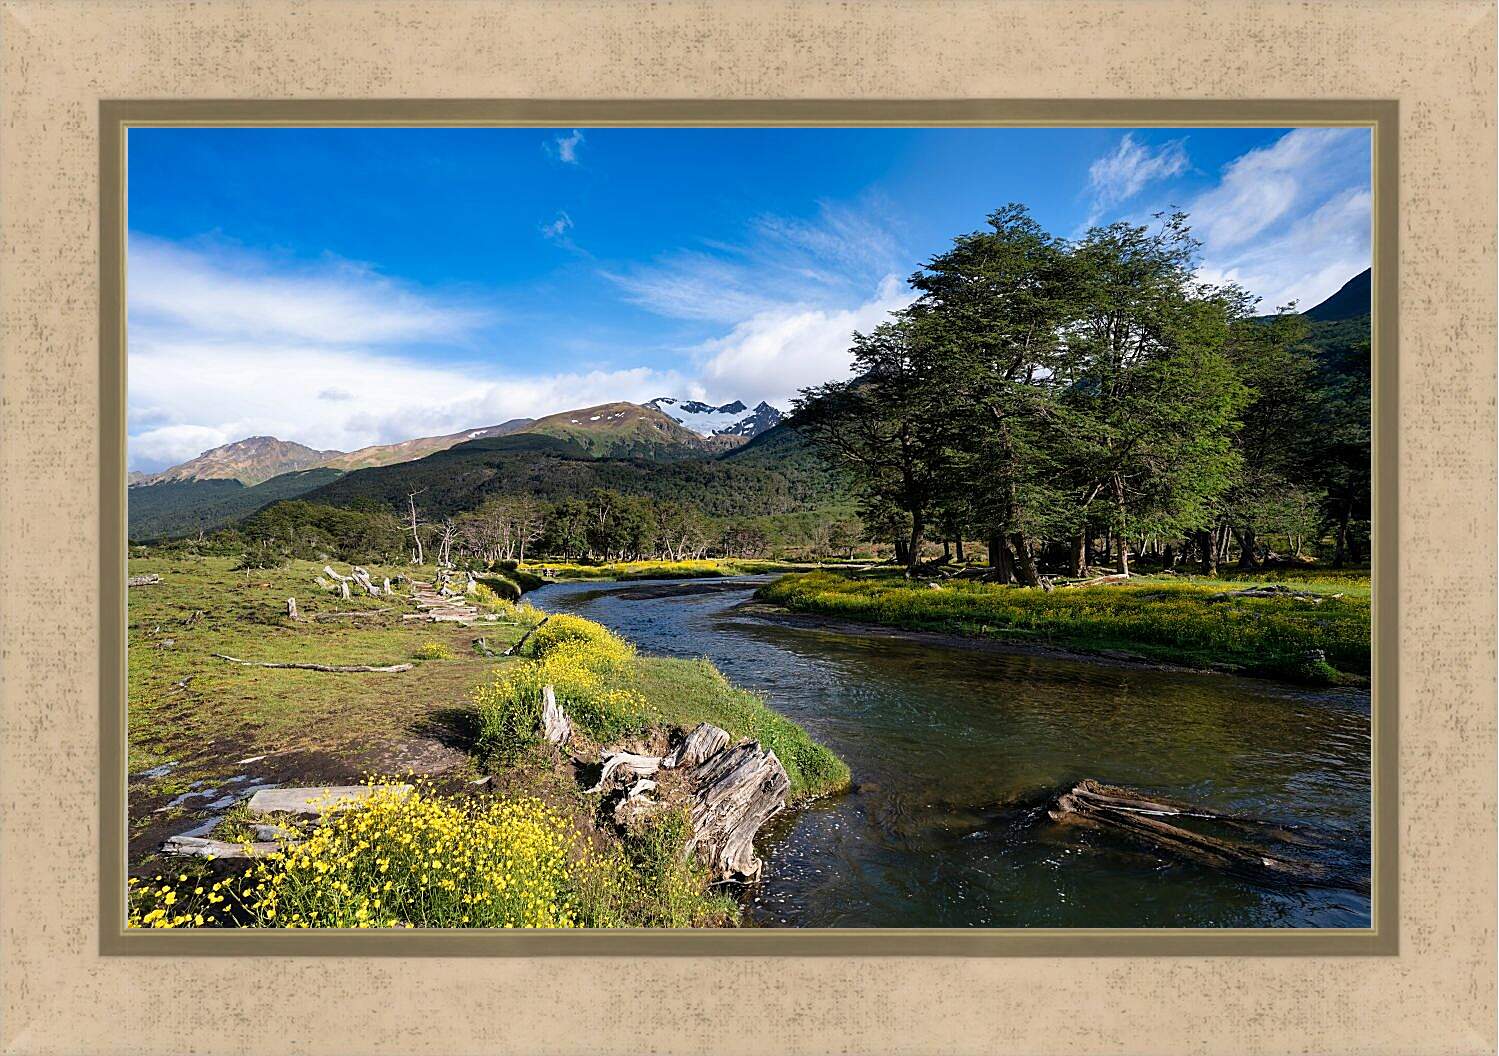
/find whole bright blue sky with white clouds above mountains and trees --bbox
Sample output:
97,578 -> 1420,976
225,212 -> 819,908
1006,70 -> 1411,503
127,128 -> 1370,470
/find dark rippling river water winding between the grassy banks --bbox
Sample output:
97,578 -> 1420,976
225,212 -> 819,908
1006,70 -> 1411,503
531,579 -> 1370,927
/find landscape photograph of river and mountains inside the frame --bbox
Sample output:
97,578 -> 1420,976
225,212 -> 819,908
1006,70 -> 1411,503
110,108 -> 1394,951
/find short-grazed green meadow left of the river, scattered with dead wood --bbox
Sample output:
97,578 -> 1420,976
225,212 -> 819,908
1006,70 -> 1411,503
127,557 -> 520,773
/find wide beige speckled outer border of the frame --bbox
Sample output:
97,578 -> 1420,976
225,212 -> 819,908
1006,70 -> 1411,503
0,0 -> 1499,1056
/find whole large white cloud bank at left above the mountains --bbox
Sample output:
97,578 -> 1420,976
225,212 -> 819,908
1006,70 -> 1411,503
129,236 -> 690,470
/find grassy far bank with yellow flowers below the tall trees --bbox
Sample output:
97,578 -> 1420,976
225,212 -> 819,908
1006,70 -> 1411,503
758,572 -> 1370,683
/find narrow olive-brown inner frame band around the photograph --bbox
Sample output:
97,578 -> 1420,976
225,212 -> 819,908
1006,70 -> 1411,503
99,99 -> 1400,957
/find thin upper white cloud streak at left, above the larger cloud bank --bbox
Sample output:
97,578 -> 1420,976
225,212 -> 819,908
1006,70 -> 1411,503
127,234 -> 487,345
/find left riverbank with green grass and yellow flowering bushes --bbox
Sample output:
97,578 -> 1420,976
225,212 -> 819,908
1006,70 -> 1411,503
129,557 -> 848,927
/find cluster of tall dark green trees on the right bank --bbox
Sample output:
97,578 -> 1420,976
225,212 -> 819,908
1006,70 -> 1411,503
791,206 -> 1370,584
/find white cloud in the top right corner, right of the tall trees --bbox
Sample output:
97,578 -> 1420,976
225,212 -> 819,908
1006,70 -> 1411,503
1186,129 -> 1373,312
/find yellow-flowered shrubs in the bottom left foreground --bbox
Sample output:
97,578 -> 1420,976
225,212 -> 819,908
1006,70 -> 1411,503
129,789 -> 738,929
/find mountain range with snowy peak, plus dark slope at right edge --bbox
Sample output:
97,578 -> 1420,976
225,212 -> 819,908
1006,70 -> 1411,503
129,272 -> 1372,540
